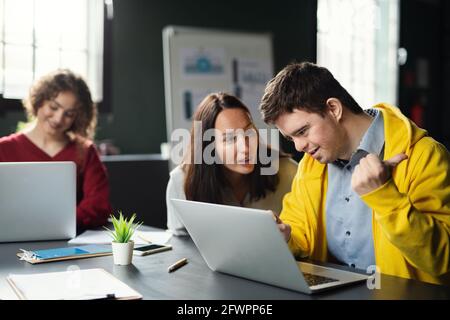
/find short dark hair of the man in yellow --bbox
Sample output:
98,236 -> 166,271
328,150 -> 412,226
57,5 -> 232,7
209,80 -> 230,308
259,62 -> 363,123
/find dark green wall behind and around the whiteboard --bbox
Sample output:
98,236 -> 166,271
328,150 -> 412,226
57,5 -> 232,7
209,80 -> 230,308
0,0 -> 317,153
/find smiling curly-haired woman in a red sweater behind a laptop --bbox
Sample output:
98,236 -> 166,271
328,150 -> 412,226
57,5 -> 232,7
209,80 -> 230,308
0,69 -> 111,231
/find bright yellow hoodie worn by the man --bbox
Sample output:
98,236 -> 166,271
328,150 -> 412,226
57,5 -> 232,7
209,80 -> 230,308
280,104 -> 450,284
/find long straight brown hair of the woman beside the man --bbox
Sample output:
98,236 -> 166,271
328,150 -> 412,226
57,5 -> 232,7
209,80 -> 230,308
182,93 -> 278,204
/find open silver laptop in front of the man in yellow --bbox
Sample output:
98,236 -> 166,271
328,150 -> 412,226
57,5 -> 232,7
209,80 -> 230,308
171,199 -> 368,294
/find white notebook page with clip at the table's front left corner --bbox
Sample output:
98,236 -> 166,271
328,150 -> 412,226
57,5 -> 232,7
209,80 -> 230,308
6,269 -> 142,300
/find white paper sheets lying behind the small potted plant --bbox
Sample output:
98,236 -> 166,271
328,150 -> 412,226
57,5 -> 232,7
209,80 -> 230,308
69,230 -> 172,245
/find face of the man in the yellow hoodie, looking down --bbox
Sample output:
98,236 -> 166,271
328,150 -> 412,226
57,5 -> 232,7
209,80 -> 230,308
275,109 -> 347,163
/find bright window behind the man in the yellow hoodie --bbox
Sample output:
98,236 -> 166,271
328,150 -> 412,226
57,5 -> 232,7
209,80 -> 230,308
317,0 -> 399,109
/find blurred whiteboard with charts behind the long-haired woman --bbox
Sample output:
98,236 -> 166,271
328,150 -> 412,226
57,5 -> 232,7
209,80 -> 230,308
163,26 -> 274,141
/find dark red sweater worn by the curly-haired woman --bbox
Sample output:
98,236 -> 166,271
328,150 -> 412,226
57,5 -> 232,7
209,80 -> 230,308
0,133 -> 112,229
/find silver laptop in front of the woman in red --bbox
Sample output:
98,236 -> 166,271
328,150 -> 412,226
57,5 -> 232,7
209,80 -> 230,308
0,162 -> 77,242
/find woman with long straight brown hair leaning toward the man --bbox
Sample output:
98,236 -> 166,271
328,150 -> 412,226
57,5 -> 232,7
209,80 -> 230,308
166,93 -> 297,235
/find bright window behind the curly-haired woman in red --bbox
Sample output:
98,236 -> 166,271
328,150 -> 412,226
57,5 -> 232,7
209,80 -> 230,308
0,0 -> 103,102
